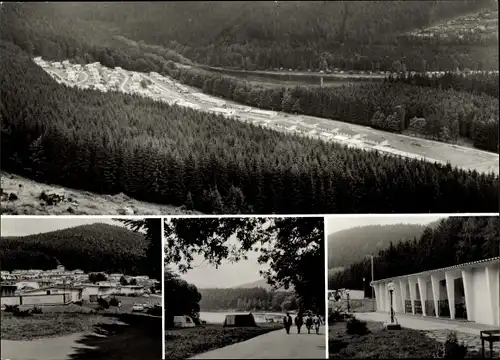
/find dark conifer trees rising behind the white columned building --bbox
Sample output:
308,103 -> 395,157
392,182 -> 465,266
328,216 -> 500,290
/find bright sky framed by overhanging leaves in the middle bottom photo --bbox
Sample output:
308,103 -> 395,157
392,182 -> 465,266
172,224 -> 269,289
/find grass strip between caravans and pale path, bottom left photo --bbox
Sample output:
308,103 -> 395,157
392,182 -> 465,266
1,311 -> 120,340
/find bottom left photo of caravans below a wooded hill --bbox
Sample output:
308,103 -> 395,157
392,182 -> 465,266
0,216 -> 163,360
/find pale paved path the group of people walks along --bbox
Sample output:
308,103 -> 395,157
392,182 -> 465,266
192,326 -> 327,359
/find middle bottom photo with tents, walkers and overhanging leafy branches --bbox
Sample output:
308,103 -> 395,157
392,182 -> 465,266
164,217 -> 327,359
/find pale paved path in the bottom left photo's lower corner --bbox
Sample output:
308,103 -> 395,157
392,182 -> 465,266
1,333 -> 100,360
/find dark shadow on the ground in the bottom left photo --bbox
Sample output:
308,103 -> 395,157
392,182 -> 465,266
70,314 -> 163,360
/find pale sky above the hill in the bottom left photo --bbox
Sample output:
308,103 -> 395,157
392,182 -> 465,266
1,217 -> 127,236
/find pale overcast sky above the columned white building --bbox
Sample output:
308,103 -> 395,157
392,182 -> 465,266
326,214 -> 445,234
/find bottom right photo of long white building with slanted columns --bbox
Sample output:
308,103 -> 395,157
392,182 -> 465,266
325,215 -> 500,359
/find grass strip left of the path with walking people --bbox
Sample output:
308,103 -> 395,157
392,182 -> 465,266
165,324 -> 283,359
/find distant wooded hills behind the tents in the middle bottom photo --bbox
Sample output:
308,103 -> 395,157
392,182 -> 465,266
199,287 -> 300,311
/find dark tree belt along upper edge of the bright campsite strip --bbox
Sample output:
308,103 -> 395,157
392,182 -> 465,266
168,68 -> 499,152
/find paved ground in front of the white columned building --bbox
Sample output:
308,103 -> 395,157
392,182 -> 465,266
354,312 -> 500,357
